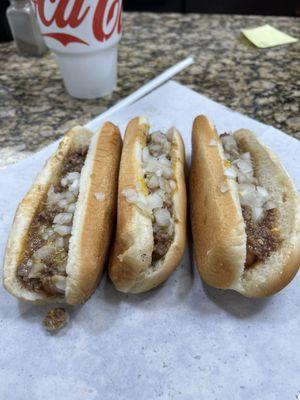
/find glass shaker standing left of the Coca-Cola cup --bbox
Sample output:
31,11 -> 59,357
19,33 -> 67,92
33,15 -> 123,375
6,0 -> 47,56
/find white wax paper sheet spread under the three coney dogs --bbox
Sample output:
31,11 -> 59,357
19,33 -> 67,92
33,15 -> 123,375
0,82 -> 300,400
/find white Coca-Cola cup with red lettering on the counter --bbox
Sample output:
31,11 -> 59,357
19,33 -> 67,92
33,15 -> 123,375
32,0 -> 122,99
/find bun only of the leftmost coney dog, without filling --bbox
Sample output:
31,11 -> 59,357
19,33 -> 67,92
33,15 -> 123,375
3,123 -> 122,304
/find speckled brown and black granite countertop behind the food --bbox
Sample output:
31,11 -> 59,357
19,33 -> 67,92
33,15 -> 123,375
0,13 -> 300,166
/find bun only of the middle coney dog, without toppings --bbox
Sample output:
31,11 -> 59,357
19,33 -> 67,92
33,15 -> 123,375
109,117 -> 186,293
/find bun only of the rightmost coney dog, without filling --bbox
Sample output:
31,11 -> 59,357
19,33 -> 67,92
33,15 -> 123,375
190,116 -> 300,297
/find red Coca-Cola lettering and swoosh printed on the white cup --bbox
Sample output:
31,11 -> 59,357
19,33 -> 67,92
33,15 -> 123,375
33,0 -> 122,46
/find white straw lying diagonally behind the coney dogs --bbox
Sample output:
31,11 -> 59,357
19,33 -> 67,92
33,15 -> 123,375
85,57 -> 194,129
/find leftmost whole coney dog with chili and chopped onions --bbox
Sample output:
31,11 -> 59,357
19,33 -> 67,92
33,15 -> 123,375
3,122 -> 122,304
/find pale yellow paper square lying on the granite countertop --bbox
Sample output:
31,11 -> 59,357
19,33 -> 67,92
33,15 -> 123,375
242,25 -> 298,48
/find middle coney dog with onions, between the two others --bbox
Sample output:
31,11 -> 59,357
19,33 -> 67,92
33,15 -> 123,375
109,117 -> 186,293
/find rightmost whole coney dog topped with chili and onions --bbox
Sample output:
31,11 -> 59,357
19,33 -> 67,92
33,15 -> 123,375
190,116 -> 300,297
